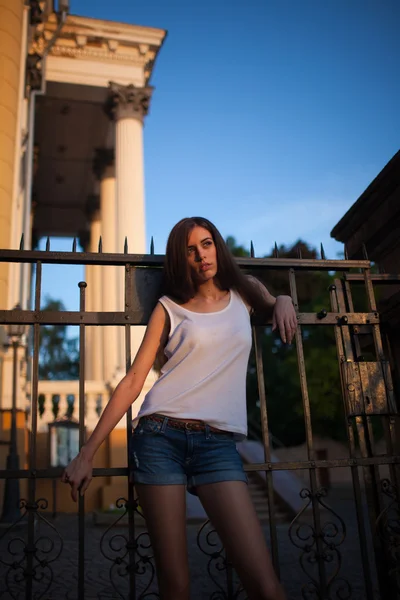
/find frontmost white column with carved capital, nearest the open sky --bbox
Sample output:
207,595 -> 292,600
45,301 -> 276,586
109,83 -> 152,377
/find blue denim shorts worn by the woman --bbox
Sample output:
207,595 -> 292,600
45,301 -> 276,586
129,417 -> 248,496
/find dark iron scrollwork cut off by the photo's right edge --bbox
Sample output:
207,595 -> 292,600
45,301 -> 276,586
375,479 -> 400,594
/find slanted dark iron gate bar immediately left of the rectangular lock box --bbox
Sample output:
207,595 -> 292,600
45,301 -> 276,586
330,279 -> 374,600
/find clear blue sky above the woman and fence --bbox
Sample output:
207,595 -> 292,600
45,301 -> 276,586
39,0 -> 400,308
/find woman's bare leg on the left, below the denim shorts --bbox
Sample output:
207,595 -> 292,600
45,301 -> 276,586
135,484 -> 190,600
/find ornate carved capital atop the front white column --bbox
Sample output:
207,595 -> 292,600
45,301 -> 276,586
105,81 -> 153,122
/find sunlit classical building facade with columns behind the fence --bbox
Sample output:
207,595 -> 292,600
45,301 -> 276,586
0,0 -> 166,503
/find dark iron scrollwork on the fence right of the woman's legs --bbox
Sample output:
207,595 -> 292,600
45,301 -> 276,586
289,488 -> 352,600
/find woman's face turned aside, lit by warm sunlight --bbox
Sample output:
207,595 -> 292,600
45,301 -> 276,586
187,226 -> 218,284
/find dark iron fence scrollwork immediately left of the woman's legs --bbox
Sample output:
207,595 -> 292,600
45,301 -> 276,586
100,498 -> 159,599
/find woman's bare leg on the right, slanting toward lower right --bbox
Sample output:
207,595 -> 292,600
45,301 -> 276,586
197,481 -> 285,600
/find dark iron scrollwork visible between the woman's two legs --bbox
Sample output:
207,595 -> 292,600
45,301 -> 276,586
197,520 -> 247,600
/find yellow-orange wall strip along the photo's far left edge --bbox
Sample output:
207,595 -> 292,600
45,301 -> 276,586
0,0 -> 24,308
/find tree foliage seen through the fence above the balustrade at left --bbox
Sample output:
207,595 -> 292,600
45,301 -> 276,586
39,296 -> 79,380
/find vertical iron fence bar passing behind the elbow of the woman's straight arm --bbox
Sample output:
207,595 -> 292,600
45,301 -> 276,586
125,265 -> 136,600
